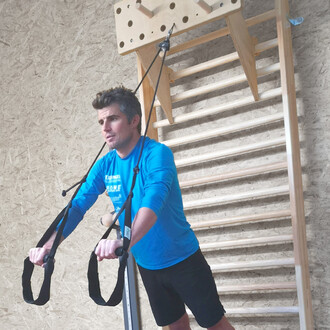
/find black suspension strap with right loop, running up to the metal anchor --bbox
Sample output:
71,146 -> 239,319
87,24 -> 174,306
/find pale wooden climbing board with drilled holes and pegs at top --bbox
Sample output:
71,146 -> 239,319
114,0 -> 242,55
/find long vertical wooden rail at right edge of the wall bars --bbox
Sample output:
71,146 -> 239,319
275,0 -> 313,330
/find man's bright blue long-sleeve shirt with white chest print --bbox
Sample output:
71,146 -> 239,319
59,138 -> 199,269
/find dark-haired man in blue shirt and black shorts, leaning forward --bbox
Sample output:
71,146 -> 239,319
29,87 -> 233,330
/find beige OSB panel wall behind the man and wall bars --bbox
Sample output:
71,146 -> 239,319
0,0 -> 330,329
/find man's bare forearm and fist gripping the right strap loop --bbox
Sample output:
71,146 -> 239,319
95,207 -> 157,261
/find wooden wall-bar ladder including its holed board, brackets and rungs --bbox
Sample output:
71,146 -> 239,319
115,0 -> 313,329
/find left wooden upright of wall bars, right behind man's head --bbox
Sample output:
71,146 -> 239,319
137,56 -> 158,141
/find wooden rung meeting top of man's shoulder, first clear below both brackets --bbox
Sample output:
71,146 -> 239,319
162,112 -> 283,148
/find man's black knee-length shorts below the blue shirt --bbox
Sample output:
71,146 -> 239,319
139,250 -> 225,328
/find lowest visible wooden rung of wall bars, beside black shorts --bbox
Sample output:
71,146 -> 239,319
187,306 -> 299,318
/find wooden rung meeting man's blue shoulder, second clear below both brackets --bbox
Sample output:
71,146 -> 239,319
175,137 -> 286,168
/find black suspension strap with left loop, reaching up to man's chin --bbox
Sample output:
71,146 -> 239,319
22,143 -> 106,306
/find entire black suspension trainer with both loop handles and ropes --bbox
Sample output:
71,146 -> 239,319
22,24 -> 174,306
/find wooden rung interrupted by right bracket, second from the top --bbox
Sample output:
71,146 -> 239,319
169,38 -> 277,82
